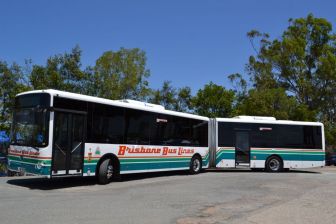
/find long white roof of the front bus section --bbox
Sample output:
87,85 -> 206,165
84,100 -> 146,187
16,89 -> 209,121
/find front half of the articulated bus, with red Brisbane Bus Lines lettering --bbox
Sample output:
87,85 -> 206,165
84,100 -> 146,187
8,90 -> 209,183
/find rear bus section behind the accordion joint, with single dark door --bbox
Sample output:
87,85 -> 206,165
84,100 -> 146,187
211,116 -> 325,172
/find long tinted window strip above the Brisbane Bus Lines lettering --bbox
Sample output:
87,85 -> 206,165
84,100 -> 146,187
69,98 -> 208,147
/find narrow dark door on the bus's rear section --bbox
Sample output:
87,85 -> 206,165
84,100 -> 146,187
235,131 -> 250,165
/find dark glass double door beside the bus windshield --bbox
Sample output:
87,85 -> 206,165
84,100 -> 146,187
51,111 -> 86,176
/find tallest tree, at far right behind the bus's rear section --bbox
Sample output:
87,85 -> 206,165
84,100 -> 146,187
246,14 -> 336,145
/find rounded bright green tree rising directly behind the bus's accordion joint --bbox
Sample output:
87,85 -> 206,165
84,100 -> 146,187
192,82 -> 235,117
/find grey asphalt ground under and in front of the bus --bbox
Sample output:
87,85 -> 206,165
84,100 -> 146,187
0,167 -> 336,224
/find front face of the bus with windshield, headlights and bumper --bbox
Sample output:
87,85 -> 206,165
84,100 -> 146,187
8,92 -> 51,176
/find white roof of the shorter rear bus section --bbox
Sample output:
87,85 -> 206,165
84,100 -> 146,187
216,116 -> 323,126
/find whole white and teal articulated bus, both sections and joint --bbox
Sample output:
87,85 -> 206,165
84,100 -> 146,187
8,90 -> 325,184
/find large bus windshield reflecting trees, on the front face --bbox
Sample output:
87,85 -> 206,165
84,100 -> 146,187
12,108 -> 49,147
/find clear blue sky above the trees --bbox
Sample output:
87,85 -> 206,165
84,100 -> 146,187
0,0 -> 336,92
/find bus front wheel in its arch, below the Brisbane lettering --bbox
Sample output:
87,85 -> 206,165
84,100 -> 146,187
96,153 -> 120,184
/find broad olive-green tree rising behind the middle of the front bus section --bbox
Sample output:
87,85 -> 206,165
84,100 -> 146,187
88,48 -> 150,100
